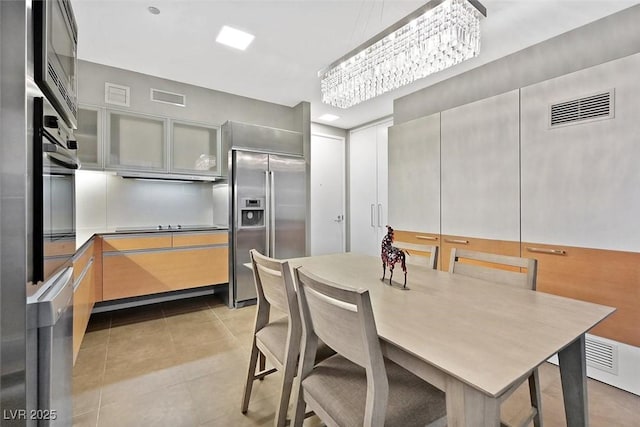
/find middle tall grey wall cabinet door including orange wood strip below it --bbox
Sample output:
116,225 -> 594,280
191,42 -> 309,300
441,90 -> 520,269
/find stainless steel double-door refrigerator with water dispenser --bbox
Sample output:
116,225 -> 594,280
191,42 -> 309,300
229,150 -> 306,307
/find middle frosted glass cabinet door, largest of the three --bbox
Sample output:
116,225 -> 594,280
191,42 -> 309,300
107,111 -> 167,171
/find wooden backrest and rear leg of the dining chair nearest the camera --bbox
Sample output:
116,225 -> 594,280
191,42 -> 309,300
295,268 -> 389,425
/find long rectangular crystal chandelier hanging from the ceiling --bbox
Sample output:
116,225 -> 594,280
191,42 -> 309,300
318,0 -> 486,108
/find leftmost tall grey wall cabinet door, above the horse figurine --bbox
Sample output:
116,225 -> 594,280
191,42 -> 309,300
388,113 -> 440,234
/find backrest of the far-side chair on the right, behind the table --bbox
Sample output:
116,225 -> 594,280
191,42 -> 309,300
449,248 -> 538,290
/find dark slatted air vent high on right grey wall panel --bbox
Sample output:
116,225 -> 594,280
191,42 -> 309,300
549,89 -> 614,128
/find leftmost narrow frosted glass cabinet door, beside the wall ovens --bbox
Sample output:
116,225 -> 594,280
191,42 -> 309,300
75,105 -> 102,169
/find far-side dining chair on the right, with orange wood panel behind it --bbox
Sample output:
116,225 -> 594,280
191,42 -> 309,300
449,248 -> 542,427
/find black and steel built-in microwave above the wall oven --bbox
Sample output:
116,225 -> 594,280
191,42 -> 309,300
33,0 -> 78,129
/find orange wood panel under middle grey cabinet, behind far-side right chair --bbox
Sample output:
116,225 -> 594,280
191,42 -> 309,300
438,235 -> 520,271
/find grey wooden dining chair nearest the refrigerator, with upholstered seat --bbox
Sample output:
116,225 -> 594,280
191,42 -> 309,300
242,249 -> 334,427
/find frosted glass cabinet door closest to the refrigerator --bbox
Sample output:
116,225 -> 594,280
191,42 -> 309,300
171,121 -> 220,175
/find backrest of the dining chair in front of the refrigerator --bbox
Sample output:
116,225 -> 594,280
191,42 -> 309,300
249,249 -> 300,325
